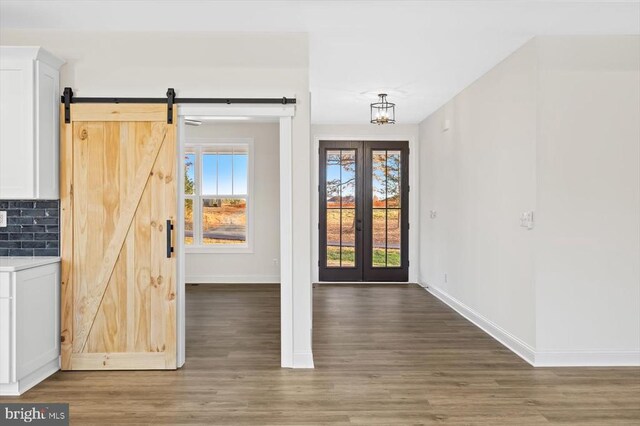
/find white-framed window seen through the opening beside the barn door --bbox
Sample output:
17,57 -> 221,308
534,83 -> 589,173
184,139 -> 253,252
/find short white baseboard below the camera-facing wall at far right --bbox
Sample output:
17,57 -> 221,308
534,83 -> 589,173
535,351 -> 640,367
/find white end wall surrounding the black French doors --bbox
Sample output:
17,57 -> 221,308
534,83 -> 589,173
311,124 -> 420,283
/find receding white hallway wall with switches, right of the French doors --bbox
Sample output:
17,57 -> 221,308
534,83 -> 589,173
420,43 -> 537,348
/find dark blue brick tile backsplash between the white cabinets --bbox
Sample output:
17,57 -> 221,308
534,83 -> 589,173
0,200 -> 60,256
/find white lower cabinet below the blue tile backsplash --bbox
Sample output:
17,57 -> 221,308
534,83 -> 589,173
0,258 -> 60,396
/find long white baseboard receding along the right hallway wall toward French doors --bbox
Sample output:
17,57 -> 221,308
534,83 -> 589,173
421,284 -> 536,366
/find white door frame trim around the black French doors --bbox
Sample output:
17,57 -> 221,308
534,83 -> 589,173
311,134 -> 420,284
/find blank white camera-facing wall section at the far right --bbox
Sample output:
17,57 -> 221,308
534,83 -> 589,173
535,36 -> 640,364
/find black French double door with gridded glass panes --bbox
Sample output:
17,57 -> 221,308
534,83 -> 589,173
318,141 -> 409,282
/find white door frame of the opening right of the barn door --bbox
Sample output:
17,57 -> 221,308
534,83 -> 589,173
176,104 -> 298,368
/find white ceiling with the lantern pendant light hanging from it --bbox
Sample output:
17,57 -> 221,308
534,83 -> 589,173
0,0 -> 640,123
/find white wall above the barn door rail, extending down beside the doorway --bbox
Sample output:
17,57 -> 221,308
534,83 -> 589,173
0,29 -> 312,365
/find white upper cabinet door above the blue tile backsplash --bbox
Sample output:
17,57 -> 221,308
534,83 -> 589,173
0,57 -> 35,199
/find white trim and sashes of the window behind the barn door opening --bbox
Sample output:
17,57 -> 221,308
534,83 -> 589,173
183,138 -> 255,254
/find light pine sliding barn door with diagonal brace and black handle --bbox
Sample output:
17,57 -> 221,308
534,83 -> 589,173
60,104 -> 177,370
